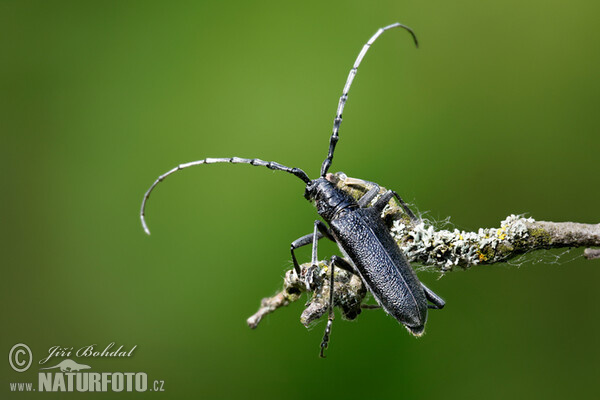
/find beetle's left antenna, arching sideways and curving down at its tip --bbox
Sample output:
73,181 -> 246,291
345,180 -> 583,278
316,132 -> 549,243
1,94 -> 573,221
140,157 -> 310,235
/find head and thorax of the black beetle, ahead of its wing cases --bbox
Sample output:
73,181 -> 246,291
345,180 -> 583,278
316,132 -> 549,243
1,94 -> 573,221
304,177 -> 358,221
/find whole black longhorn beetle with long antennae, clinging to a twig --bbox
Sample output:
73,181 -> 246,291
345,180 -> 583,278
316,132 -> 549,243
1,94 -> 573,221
140,23 -> 445,357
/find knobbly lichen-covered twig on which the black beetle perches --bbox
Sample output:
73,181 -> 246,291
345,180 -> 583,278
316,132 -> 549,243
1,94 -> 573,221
247,173 -> 600,328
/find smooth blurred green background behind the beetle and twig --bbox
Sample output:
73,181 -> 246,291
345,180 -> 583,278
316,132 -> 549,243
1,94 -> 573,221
0,0 -> 600,399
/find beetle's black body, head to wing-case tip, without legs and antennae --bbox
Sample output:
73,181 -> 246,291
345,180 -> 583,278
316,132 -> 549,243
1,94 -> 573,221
305,178 -> 436,336
